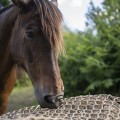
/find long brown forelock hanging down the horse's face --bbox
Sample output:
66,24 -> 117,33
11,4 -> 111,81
34,0 -> 64,53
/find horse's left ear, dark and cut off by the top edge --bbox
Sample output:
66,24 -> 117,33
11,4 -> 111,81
12,0 -> 31,8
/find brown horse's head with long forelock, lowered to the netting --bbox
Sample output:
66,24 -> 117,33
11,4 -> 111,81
11,0 -> 64,108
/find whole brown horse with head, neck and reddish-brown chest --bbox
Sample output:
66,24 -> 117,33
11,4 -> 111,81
0,0 -> 64,114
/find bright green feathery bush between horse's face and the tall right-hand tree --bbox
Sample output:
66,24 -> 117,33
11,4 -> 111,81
59,31 -> 120,96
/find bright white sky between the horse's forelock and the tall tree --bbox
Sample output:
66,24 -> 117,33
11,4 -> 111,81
58,0 -> 103,31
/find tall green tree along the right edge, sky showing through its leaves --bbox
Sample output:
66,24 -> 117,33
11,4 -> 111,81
87,0 -> 120,94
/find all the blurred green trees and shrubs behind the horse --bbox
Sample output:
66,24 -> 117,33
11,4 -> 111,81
0,0 -> 120,110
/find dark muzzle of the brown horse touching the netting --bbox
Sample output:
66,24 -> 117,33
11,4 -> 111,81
35,83 -> 64,109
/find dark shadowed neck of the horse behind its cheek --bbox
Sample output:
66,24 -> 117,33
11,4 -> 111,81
0,7 -> 18,79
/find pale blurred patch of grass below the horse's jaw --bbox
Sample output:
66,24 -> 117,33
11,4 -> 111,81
7,84 -> 37,112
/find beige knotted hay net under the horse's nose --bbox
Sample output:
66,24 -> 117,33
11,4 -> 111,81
0,95 -> 120,120
